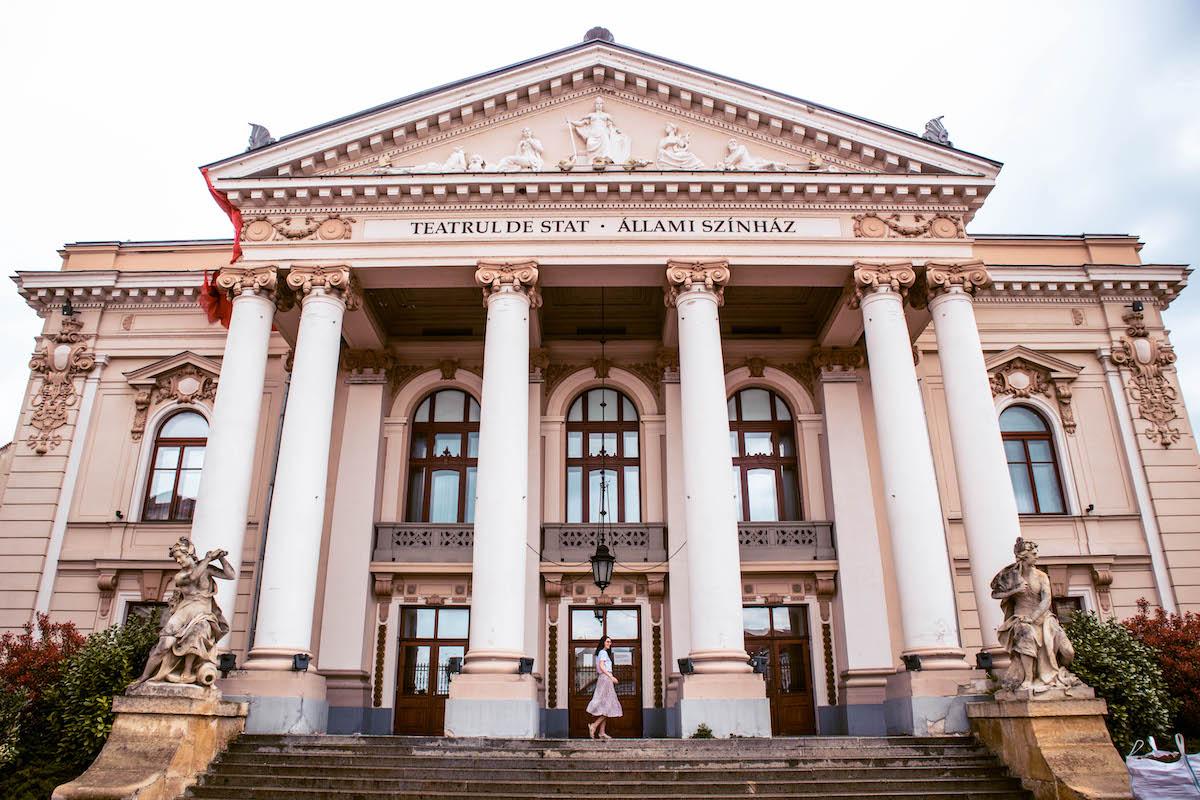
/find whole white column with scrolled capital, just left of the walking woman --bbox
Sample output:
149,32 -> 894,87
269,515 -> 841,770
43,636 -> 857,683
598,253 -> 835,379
445,261 -> 539,738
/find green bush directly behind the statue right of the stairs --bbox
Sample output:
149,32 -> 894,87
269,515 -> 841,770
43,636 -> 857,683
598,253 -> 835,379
1063,613 -> 1176,754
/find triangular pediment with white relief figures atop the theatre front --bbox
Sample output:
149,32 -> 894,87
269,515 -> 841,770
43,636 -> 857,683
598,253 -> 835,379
210,41 -> 1000,181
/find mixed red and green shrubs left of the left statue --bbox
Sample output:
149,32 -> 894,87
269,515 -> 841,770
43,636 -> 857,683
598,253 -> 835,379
0,615 -> 158,800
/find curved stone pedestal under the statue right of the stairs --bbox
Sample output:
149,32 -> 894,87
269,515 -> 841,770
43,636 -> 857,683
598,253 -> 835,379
967,699 -> 1133,800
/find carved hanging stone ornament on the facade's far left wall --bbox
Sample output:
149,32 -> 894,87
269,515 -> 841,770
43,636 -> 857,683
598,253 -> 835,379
25,317 -> 96,456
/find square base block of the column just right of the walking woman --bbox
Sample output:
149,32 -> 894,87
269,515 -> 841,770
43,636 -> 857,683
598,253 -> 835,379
677,673 -> 770,739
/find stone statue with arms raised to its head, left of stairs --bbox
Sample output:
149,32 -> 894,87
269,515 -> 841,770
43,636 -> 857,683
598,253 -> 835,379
133,536 -> 235,686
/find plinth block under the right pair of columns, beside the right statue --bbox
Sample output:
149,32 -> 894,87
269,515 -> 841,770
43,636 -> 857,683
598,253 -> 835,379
883,669 -> 990,736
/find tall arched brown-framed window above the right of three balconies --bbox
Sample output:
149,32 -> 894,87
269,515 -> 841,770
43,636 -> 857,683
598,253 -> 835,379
730,389 -> 800,522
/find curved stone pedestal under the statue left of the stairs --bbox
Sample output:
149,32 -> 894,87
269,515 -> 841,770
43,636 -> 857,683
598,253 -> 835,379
54,684 -> 246,800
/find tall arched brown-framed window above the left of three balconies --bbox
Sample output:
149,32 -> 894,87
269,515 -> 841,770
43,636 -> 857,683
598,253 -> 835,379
406,389 -> 479,523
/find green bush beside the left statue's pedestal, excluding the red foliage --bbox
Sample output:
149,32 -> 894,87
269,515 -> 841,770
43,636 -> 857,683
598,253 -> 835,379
0,619 -> 158,800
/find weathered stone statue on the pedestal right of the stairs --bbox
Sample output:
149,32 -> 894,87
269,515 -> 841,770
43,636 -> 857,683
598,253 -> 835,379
991,536 -> 1094,699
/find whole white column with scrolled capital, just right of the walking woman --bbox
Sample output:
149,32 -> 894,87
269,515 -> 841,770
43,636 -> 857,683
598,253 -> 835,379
666,261 -> 770,736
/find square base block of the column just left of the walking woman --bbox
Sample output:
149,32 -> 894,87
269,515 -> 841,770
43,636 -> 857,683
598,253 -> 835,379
445,673 -> 541,739
